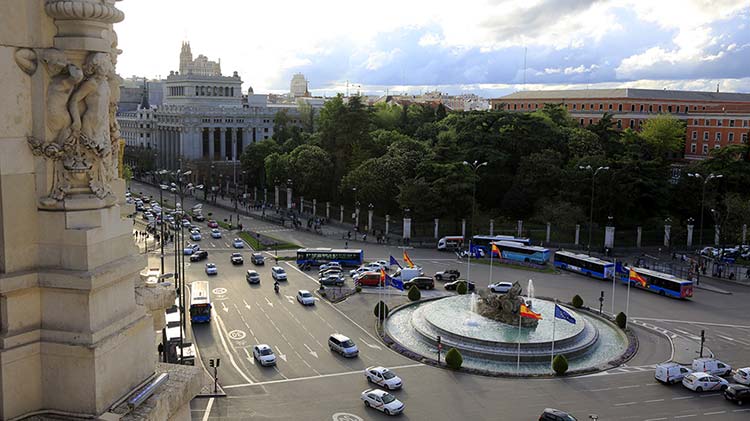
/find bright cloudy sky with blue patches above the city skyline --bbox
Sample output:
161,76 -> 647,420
116,0 -> 750,97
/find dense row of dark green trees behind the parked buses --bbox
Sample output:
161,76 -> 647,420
241,96 -> 750,238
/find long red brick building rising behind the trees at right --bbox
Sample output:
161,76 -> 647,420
490,88 -> 750,159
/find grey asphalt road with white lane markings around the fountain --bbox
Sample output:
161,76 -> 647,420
134,183 -> 750,421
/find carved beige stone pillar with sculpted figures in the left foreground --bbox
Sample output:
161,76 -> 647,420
0,0 -> 202,420
